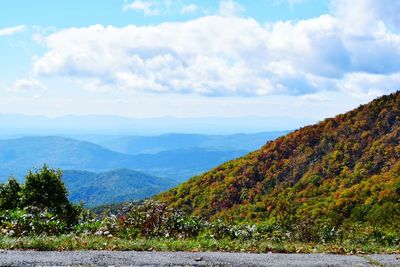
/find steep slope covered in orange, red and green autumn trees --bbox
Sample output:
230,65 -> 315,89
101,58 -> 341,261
157,92 -> 400,225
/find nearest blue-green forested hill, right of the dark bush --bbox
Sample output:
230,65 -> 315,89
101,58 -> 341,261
63,169 -> 177,207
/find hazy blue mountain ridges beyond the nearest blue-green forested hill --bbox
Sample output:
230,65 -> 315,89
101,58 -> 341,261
0,132 -> 283,181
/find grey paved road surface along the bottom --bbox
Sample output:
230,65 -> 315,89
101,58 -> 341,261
0,251 -> 400,266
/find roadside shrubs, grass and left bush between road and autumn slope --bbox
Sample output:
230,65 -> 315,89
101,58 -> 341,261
0,166 -> 400,253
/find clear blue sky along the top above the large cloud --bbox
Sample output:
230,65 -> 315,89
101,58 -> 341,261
0,0 -> 330,28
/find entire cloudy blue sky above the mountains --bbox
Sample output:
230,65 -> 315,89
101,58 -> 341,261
0,0 -> 400,120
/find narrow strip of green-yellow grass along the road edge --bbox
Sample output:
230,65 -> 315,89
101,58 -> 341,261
0,235 -> 400,254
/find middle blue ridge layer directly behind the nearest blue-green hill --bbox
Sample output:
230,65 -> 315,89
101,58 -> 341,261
0,136 -> 246,181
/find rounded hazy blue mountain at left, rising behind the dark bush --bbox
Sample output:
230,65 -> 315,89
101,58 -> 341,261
0,136 -> 131,180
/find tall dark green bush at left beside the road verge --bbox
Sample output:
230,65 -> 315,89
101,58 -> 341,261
0,165 -> 83,235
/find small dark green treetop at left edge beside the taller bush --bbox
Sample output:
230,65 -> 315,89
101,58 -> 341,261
0,177 -> 21,210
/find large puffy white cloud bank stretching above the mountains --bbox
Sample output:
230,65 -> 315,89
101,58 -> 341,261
34,0 -> 400,96
